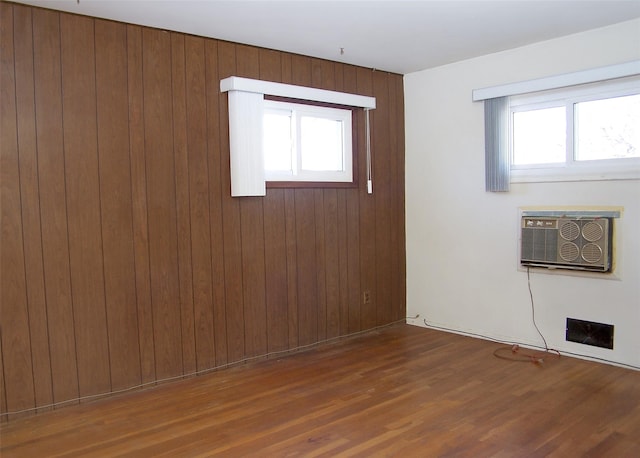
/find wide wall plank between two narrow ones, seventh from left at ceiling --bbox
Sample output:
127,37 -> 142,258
142,29 -> 182,379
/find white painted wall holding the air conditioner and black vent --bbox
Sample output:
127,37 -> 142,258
404,20 -> 640,367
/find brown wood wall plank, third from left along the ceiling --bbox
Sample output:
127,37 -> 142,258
32,7 -> 79,402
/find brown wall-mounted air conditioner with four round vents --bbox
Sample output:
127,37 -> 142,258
520,216 -> 613,272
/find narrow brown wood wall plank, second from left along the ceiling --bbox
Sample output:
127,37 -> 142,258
14,3 -> 53,410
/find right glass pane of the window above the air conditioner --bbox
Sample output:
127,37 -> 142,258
574,94 -> 640,161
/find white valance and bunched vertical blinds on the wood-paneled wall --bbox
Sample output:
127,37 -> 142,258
220,76 -> 376,197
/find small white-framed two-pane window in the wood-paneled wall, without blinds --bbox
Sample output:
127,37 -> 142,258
263,100 -> 353,183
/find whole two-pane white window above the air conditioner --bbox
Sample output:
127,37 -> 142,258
509,78 -> 640,181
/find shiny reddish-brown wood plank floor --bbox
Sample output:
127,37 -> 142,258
0,324 -> 640,458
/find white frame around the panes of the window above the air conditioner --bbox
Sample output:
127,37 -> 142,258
509,76 -> 640,183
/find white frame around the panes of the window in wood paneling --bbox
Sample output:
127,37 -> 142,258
264,100 -> 353,183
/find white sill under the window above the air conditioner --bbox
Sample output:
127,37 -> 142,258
511,164 -> 640,183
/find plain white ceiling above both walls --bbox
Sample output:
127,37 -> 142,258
16,0 -> 640,74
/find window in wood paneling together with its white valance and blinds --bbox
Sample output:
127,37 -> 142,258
220,76 -> 376,197
